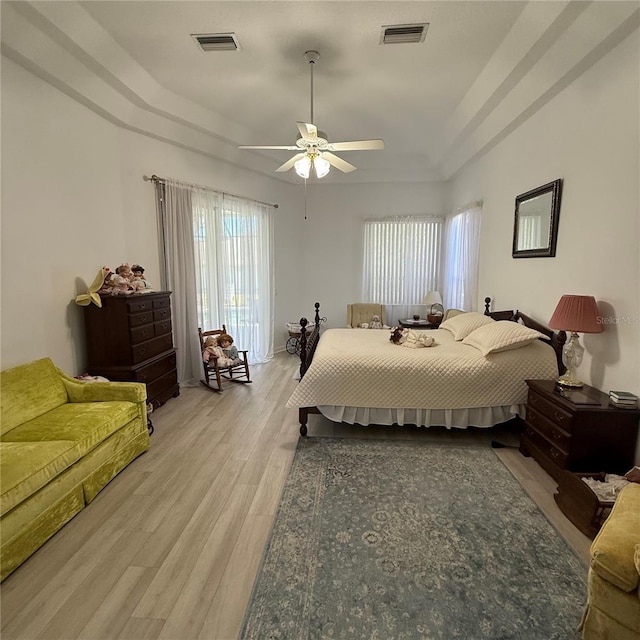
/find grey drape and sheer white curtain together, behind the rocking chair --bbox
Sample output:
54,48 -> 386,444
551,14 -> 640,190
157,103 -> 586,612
156,179 -> 274,384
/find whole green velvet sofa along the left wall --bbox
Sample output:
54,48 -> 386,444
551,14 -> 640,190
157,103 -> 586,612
0,358 -> 149,580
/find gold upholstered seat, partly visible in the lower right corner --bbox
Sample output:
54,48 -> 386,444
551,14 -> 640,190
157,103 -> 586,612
581,483 -> 640,640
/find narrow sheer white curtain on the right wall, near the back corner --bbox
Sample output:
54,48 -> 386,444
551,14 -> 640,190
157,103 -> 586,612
442,202 -> 482,311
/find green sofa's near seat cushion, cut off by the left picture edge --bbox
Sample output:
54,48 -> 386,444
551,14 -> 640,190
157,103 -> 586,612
0,440 -> 80,515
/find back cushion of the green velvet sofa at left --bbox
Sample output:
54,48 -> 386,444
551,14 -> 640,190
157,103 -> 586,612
0,358 -> 68,434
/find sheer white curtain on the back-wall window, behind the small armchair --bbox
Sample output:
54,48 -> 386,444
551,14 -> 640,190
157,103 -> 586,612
362,216 -> 444,324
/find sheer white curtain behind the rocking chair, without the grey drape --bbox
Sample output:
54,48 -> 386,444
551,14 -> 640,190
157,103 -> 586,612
192,189 -> 275,362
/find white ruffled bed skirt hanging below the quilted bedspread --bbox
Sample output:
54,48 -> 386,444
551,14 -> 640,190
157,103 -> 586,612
318,404 -> 526,429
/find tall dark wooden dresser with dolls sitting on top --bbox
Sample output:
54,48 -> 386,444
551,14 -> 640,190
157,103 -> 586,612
84,291 -> 180,408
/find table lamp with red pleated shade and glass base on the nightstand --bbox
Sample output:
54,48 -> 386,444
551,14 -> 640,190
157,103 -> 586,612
549,295 -> 602,387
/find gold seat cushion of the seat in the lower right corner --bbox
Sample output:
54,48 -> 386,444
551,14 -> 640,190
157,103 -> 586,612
591,483 -> 640,591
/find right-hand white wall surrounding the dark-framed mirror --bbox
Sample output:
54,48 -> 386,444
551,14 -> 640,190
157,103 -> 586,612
451,31 -> 640,394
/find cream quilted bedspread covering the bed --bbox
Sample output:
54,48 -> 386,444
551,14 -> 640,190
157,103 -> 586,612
287,329 -> 558,409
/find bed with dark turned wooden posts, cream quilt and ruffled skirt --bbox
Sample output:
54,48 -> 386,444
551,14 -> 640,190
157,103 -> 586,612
286,298 -> 566,436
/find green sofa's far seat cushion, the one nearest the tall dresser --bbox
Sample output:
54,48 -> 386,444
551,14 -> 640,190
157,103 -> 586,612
2,402 -> 139,457
